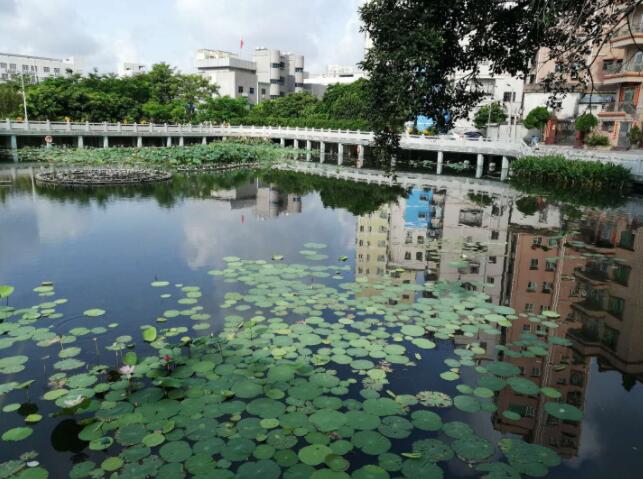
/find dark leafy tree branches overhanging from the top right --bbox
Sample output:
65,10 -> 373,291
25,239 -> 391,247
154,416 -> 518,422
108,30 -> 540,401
360,0 -> 643,169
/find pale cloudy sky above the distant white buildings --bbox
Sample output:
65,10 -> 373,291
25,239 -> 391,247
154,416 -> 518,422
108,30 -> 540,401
0,0 -> 364,73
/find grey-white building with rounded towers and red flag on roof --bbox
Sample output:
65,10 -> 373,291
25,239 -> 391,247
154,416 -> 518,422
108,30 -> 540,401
195,48 -> 304,105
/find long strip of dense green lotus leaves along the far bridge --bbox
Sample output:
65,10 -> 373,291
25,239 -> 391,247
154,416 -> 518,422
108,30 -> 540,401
15,141 -> 292,167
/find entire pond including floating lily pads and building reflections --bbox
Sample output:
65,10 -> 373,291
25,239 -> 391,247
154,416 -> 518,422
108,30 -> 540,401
0,169 -> 643,479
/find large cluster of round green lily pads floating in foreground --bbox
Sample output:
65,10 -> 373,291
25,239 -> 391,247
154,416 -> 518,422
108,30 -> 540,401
0,243 -> 582,479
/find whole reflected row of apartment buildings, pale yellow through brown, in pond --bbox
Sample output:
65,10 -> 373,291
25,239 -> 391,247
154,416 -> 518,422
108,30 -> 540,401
356,180 -> 643,458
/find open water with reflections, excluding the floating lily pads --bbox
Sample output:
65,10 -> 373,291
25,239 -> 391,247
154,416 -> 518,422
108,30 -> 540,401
0,167 -> 643,479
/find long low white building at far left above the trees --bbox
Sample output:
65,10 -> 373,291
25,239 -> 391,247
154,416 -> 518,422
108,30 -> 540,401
0,53 -> 78,83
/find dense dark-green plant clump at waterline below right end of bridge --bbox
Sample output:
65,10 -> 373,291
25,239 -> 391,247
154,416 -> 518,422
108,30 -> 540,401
511,155 -> 630,193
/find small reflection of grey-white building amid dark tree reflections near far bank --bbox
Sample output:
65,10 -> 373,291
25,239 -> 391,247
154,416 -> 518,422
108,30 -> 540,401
210,180 -> 302,219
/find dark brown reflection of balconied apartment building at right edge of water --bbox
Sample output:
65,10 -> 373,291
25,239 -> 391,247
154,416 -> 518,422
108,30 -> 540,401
571,215 -> 643,381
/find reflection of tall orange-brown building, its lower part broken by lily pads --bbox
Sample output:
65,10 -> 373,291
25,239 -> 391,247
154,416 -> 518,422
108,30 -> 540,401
494,221 -> 589,458
